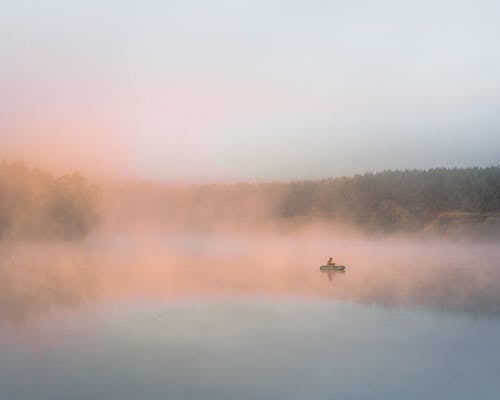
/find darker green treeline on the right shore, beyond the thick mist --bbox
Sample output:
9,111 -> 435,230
275,167 -> 500,231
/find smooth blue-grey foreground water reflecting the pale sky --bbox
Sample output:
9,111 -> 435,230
0,300 -> 500,400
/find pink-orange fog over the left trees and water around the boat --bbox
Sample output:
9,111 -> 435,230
0,164 -> 500,324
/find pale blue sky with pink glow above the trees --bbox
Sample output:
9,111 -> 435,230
0,0 -> 500,182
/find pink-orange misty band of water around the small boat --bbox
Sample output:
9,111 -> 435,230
0,237 -> 500,323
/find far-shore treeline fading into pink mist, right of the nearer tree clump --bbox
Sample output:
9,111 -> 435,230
106,167 -> 500,232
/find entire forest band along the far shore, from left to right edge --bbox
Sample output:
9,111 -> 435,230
0,162 -> 500,240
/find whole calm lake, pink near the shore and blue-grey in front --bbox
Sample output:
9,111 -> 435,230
0,235 -> 500,400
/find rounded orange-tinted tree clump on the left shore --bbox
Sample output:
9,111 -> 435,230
0,162 -> 99,240
